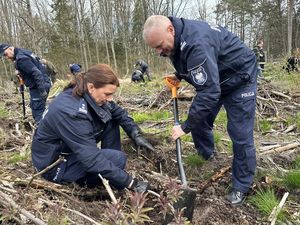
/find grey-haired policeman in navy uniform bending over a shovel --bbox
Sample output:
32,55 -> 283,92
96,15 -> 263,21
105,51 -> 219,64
143,15 -> 258,204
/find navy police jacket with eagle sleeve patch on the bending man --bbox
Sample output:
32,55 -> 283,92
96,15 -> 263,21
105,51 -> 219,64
169,17 -> 257,133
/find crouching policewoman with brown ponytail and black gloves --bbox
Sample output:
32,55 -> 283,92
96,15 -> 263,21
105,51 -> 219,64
32,64 -> 154,192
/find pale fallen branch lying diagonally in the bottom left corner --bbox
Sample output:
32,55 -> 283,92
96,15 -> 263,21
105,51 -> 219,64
0,191 -> 46,225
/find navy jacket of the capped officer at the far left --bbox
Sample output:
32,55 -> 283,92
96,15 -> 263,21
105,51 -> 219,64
14,48 -> 50,94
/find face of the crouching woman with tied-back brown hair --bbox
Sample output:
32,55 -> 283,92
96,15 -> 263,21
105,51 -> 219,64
87,83 -> 117,105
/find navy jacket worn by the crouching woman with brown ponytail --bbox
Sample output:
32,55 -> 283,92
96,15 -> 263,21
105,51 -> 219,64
32,88 -> 138,187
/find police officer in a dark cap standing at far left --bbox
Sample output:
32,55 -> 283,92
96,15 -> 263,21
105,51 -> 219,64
0,44 -> 51,124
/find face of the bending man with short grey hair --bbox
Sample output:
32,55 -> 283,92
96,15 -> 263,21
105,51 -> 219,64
145,25 -> 175,57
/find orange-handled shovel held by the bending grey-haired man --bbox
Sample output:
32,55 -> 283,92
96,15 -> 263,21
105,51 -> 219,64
165,77 -> 196,224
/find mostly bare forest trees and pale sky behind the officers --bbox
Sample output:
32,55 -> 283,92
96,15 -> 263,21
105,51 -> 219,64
0,0 -> 300,81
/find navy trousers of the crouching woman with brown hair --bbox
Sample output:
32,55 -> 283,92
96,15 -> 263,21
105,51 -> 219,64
44,122 -> 127,189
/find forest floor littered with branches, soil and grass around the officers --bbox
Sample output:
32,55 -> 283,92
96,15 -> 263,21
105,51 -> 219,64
0,76 -> 300,225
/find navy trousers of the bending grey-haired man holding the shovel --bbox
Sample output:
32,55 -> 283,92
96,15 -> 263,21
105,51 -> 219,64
191,83 -> 256,193
